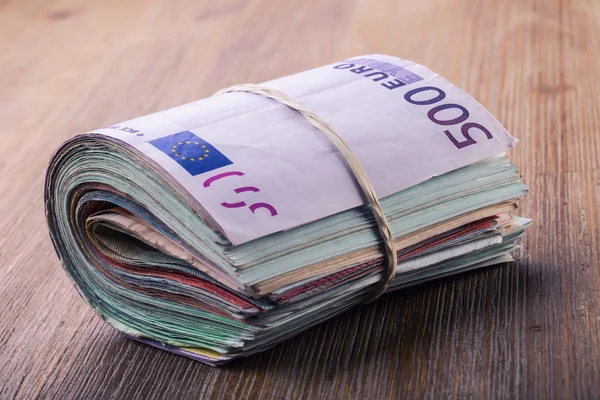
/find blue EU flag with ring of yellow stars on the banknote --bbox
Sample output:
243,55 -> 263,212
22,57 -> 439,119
149,131 -> 233,176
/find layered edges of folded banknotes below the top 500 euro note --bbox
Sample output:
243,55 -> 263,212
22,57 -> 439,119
45,54 -> 531,365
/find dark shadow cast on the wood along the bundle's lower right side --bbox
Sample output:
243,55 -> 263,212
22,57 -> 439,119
221,262 -> 558,380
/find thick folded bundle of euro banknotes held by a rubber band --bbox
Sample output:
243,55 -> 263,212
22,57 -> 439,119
45,55 -> 531,365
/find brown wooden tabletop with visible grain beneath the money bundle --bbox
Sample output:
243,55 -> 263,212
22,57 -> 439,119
0,0 -> 600,399
